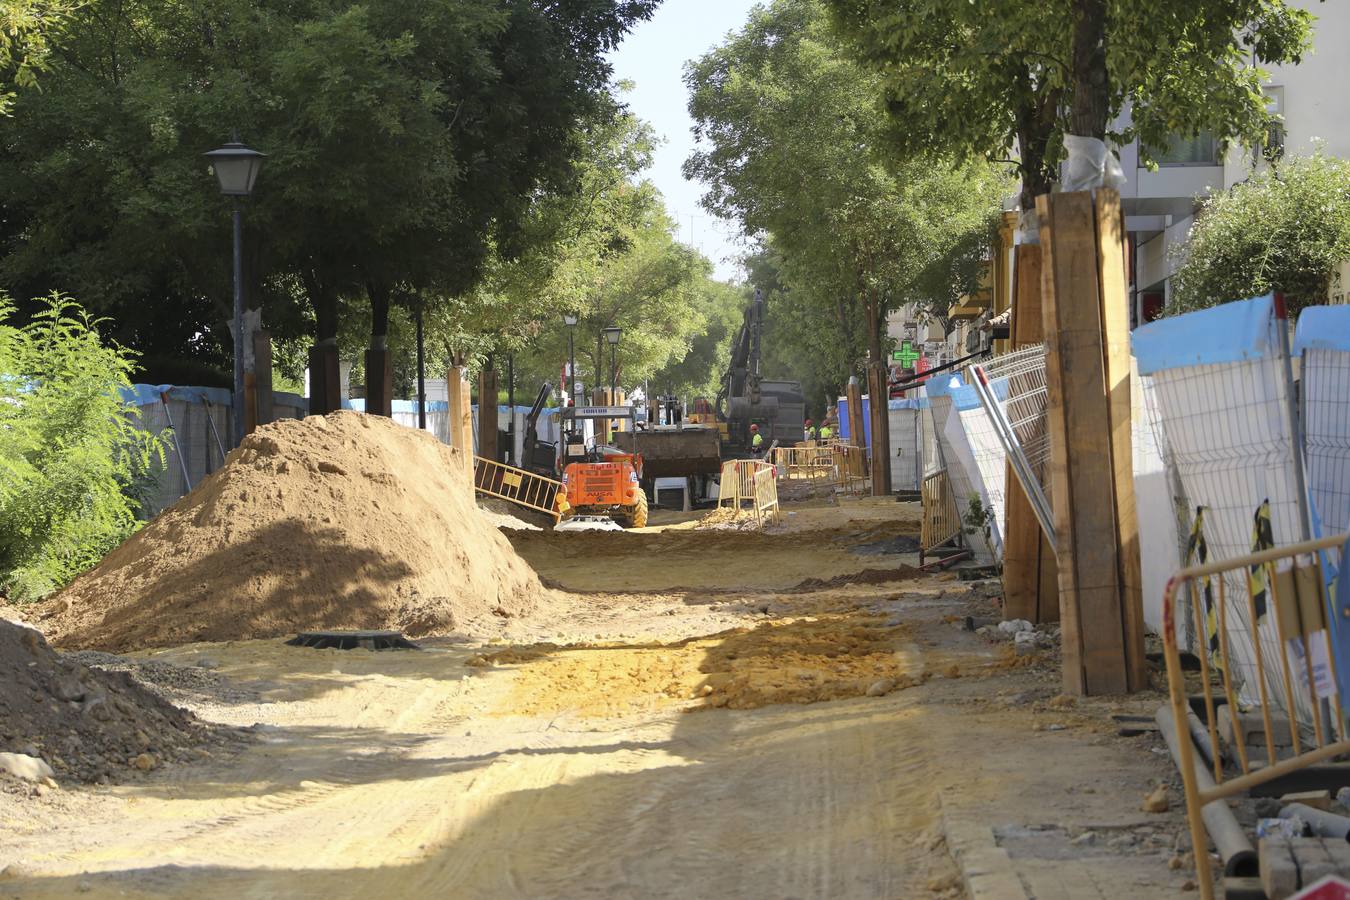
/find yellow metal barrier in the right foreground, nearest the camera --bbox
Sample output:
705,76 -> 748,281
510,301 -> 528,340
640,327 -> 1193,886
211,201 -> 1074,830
1162,534 -> 1350,900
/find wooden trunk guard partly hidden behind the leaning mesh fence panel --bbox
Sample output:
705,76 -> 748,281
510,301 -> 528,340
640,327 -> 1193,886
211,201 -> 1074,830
1003,244 -> 1060,623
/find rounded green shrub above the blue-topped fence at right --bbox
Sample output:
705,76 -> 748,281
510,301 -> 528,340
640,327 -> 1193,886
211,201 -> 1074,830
1166,152 -> 1350,316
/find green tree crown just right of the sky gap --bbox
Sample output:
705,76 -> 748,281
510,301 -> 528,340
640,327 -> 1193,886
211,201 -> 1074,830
684,0 -> 1011,406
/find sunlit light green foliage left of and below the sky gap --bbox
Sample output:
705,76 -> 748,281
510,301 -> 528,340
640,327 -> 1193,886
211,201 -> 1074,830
415,98 -> 740,404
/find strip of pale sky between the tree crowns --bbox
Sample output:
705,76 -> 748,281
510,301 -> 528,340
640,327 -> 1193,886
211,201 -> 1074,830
612,0 -> 756,281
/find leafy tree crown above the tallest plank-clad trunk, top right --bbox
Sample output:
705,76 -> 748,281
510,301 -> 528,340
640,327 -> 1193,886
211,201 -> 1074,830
825,0 -> 1311,209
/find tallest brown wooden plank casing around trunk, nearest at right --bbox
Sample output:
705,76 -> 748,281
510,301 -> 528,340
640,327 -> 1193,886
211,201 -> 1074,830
1037,190 -> 1142,695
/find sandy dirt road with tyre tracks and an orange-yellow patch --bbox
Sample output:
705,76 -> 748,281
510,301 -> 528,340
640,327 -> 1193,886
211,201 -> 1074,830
0,501 -> 1191,900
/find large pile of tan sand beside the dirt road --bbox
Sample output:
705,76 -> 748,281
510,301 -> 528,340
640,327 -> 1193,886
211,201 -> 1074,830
39,412 -> 543,650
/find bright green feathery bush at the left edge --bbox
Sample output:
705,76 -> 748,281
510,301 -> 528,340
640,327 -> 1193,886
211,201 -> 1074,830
0,294 -> 163,602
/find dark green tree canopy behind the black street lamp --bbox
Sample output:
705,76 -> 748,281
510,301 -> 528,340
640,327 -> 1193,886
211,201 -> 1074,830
0,0 -> 655,380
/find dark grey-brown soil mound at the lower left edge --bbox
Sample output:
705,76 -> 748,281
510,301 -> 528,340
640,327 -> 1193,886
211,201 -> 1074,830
0,619 -> 224,781
